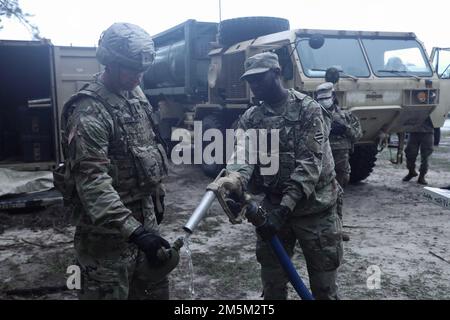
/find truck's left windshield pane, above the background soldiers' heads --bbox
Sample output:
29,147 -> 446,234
297,37 -> 370,78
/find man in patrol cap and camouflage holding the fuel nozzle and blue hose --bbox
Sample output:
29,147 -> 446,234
222,52 -> 343,300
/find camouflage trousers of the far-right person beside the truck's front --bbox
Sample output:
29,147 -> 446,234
405,132 -> 434,174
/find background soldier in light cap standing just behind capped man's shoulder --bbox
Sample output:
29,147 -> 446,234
316,82 -> 362,241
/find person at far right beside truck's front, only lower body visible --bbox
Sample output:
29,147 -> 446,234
403,117 -> 434,185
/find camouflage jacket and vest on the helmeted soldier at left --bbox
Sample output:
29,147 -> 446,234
58,75 -> 167,238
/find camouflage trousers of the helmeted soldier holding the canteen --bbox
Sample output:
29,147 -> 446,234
74,199 -> 169,300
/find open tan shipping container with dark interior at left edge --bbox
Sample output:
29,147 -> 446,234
0,40 -> 101,170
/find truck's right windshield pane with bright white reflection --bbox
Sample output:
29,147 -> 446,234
362,39 -> 433,78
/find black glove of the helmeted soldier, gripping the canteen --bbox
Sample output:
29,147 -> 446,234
130,226 -> 170,265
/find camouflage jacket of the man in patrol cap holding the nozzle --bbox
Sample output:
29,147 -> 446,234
227,89 -> 337,216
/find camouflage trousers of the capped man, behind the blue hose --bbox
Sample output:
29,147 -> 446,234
256,201 -> 343,300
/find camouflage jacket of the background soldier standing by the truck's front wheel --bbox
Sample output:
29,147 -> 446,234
330,106 -> 363,150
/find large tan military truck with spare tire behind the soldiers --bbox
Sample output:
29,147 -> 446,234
144,17 -> 449,182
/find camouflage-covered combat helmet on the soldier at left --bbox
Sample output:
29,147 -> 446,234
96,23 -> 155,72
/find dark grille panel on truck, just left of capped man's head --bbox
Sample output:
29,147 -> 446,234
222,51 -> 248,100
